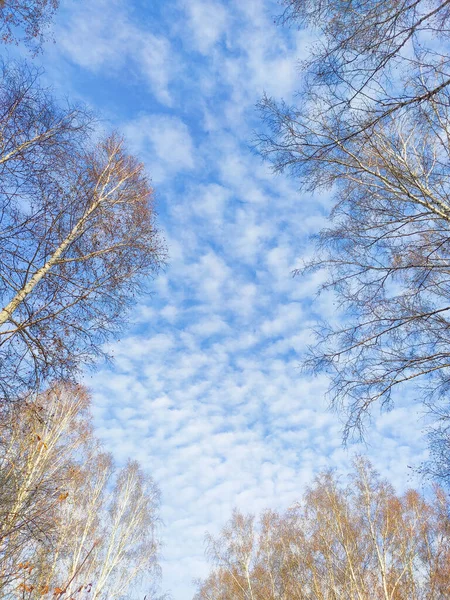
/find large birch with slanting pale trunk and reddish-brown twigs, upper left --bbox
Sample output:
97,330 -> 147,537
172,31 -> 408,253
0,61 -> 164,399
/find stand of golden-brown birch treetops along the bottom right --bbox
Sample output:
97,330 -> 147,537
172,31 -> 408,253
195,459 -> 450,600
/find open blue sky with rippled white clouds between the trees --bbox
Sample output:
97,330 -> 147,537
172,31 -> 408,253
14,0 -> 432,600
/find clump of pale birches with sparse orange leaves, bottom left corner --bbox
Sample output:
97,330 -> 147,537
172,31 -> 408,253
0,384 -> 159,600
